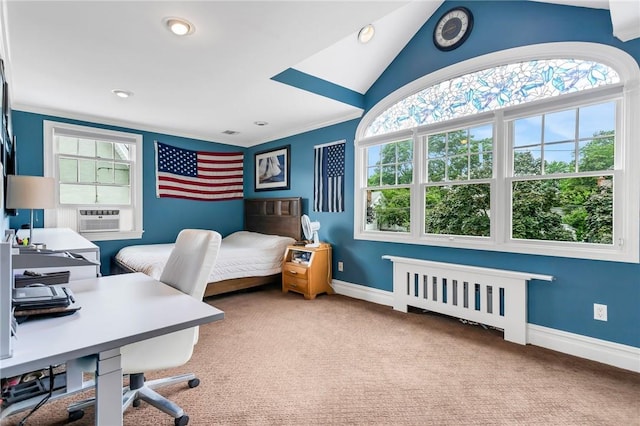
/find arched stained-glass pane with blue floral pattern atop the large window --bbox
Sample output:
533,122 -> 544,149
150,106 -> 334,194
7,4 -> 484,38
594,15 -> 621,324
365,59 -> 620,137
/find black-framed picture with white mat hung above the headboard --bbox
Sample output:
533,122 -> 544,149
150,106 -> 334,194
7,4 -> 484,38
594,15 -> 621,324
254,145 -> 291,191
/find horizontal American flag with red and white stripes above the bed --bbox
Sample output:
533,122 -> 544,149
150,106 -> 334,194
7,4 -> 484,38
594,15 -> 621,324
156,142 -> 244,201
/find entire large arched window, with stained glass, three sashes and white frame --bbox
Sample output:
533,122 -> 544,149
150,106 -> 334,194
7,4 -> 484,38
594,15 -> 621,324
355,43 -> 640,262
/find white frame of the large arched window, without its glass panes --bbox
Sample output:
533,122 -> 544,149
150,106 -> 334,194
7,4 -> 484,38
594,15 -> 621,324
354,42 -> 640,263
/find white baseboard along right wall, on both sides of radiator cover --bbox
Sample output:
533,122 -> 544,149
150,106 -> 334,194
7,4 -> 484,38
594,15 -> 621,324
332,280 -> 640,373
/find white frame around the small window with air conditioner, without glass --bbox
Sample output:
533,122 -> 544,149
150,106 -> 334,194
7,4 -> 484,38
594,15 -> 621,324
43,121 -> 144,241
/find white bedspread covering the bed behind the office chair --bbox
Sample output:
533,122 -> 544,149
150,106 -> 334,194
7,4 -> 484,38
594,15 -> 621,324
116,231 -> 295,282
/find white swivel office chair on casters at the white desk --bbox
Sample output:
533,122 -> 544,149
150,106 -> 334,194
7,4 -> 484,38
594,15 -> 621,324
67,229 -> 222,426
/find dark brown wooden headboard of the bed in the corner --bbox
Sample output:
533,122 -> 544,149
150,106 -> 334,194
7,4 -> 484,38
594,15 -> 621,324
244,197 -> 302,241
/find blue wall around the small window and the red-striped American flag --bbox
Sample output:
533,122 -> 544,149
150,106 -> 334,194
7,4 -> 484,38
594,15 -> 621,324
10,111 -> 245,275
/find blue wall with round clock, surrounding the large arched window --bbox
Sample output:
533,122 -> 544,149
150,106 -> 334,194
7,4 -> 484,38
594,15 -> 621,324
245,1 -> 640,347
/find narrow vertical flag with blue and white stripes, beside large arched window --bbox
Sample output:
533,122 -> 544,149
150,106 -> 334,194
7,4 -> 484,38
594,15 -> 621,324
313,141 -> 345,212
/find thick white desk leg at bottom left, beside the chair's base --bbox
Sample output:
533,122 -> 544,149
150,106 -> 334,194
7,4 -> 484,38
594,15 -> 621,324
96,348 -> 122,426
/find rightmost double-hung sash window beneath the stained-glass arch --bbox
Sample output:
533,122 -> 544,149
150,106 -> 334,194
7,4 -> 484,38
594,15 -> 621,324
508,100 -> 617,246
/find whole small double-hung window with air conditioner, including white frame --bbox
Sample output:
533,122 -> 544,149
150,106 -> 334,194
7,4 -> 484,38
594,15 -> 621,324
44,121 -> 142,240
